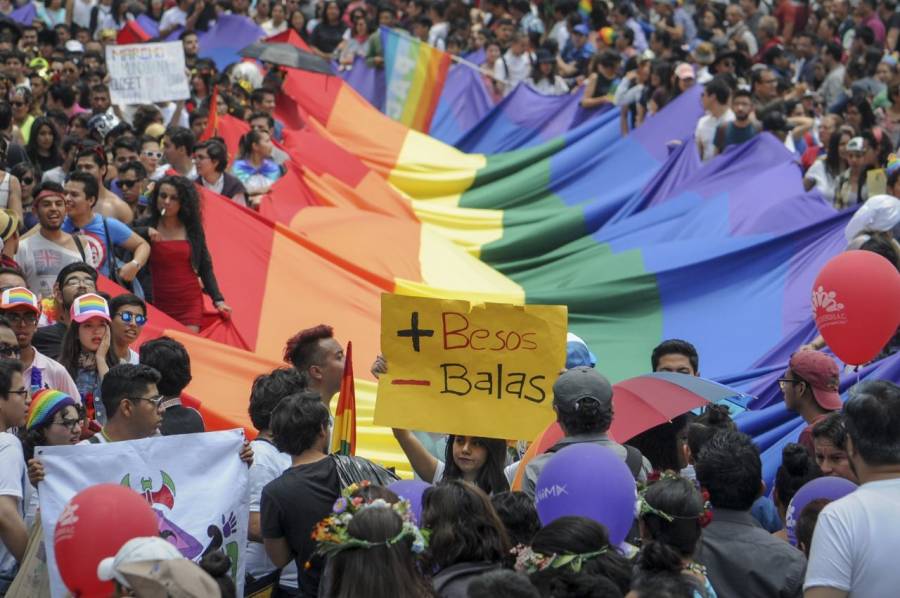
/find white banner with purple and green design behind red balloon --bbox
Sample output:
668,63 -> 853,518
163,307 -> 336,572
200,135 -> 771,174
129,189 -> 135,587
35,430 -> 250,598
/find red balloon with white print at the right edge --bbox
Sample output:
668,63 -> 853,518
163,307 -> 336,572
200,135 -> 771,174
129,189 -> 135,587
812,251 -> 900,365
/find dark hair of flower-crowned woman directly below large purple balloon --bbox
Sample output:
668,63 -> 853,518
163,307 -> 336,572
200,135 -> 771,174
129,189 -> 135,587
530,516 -> 631,597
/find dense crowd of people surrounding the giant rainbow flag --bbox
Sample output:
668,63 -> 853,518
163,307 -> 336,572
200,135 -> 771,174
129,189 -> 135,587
0,0 -> 900,598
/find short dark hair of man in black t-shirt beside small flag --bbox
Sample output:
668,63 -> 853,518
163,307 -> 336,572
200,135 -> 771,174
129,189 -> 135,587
270,390 -> 330,455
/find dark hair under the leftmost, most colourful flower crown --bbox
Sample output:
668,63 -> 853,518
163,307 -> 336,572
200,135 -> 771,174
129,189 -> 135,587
328,506 -> 434,598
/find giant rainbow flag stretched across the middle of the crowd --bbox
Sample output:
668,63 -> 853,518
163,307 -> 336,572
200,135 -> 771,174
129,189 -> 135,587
119,65 -> 896,482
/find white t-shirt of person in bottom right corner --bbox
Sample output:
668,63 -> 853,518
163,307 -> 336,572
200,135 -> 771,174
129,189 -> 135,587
803,478 -> 900,597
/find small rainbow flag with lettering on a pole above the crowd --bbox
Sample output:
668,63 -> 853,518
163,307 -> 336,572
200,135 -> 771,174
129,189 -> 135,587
381,27 -> 450,132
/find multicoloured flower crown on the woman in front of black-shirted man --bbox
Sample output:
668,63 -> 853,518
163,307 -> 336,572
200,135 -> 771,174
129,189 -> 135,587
312,480 -> 428,556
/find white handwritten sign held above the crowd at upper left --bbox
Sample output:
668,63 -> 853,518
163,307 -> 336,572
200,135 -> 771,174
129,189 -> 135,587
106,42 -> 191,106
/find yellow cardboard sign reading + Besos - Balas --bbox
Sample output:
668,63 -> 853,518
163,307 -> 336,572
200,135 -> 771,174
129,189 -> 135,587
375,294 -> 568,440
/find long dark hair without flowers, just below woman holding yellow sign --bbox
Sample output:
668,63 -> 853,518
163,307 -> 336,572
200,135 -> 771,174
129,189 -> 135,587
422,480 -> 510,569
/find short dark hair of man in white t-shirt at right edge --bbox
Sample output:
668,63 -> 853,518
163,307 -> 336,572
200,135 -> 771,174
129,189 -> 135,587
843,380 -> 900,465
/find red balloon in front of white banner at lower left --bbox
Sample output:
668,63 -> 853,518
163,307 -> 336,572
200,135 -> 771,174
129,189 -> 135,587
53,484 -> 159,598
